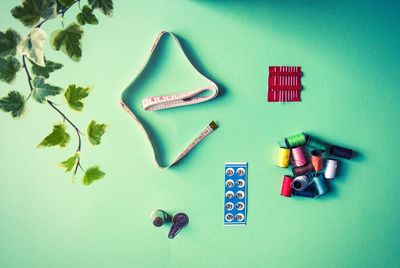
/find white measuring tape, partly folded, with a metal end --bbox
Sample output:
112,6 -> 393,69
120,31 -> 218,169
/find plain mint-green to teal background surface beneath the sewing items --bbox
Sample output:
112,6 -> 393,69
0,0 -> 400,267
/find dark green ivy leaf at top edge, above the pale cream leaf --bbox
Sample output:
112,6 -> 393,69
11,0 -> 57,27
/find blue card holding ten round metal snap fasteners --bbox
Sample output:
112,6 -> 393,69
224,162 -> 247,226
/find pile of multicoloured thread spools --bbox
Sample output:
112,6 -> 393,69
277,133 -> 353,198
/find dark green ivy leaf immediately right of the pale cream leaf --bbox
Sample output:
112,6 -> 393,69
50,23 -> 83,61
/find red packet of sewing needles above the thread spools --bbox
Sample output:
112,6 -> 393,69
267,66 -> 302,102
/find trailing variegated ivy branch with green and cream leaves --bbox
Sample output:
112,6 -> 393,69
0,0 -> 113,185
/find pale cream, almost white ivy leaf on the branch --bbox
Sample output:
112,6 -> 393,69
17,28 -> 47,67
